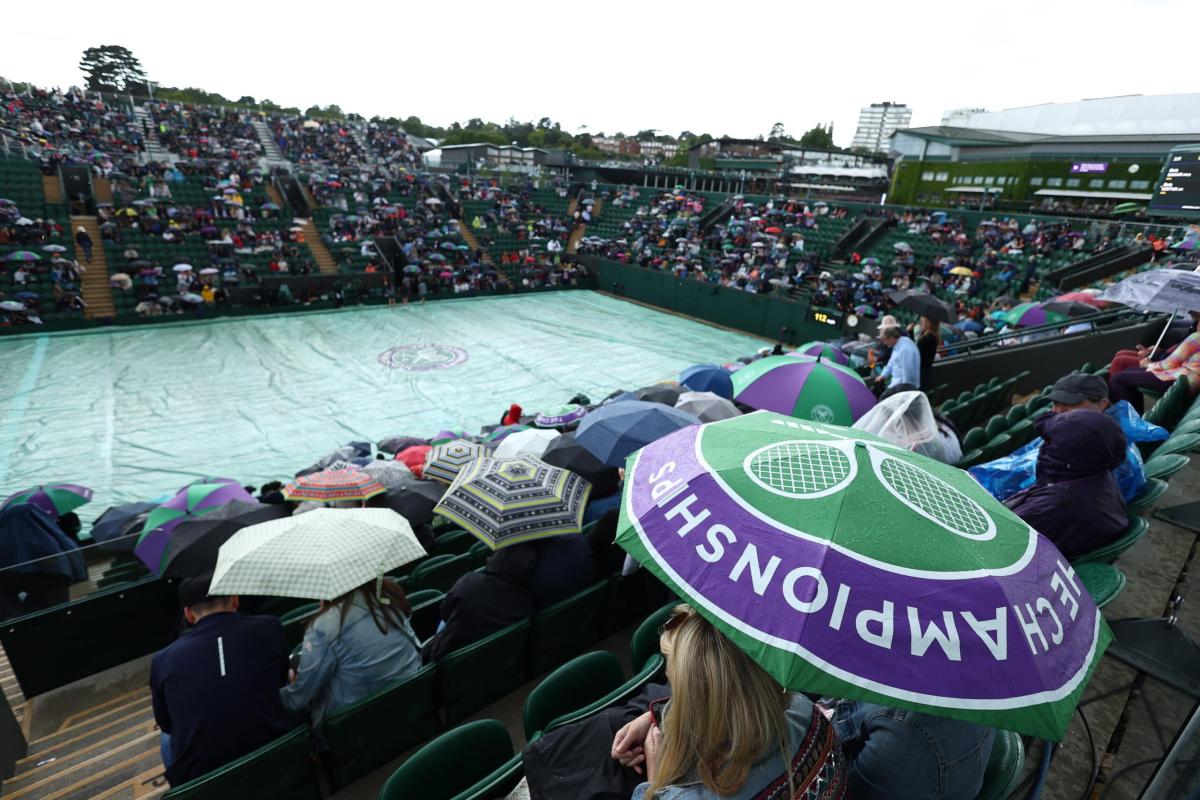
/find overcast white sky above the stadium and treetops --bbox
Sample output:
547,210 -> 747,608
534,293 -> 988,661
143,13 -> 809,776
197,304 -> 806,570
0,0 -> 1196,145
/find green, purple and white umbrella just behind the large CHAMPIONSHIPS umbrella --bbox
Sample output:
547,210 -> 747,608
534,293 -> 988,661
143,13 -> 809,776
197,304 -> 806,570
733,355 -> 875,425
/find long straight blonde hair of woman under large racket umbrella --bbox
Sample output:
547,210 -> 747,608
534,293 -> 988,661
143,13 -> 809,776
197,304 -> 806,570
647,606 -> 792,798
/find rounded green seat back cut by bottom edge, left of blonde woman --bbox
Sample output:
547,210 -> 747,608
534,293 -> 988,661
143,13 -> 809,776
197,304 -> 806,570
379,720 -> 520,800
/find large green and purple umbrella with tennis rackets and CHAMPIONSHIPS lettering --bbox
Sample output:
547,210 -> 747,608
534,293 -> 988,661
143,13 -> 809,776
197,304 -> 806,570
617,414 -> 1111,739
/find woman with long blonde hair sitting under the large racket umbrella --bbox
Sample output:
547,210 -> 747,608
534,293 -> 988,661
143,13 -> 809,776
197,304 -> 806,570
612,606 -> 846,800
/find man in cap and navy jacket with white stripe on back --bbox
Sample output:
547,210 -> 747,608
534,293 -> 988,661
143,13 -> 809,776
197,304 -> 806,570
150,575 -> 296,786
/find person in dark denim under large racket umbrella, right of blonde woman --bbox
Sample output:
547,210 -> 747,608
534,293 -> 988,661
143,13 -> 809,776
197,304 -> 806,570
833,700 -> 996,800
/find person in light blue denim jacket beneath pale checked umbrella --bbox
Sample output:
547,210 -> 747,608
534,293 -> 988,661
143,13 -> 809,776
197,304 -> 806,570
280,581 -> 421,724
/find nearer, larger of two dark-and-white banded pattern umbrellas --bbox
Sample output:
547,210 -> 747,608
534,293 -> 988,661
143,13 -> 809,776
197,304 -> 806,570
436,456 -> 592,551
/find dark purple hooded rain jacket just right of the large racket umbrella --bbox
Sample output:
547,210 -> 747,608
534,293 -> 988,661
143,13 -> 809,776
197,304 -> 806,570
1004,409 -> 1129,559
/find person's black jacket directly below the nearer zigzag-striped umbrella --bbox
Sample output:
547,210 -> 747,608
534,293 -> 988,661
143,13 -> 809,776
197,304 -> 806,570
421,545 -> 538,663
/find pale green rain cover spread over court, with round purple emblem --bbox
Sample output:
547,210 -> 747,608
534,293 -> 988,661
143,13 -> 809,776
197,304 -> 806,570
0,291 -> 763,522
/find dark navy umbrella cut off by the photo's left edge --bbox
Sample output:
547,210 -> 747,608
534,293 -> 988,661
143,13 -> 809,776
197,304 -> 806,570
0,503 -> 88,585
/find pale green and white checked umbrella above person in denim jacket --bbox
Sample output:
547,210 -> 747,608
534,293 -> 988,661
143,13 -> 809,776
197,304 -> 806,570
209,509 -> 426,600
